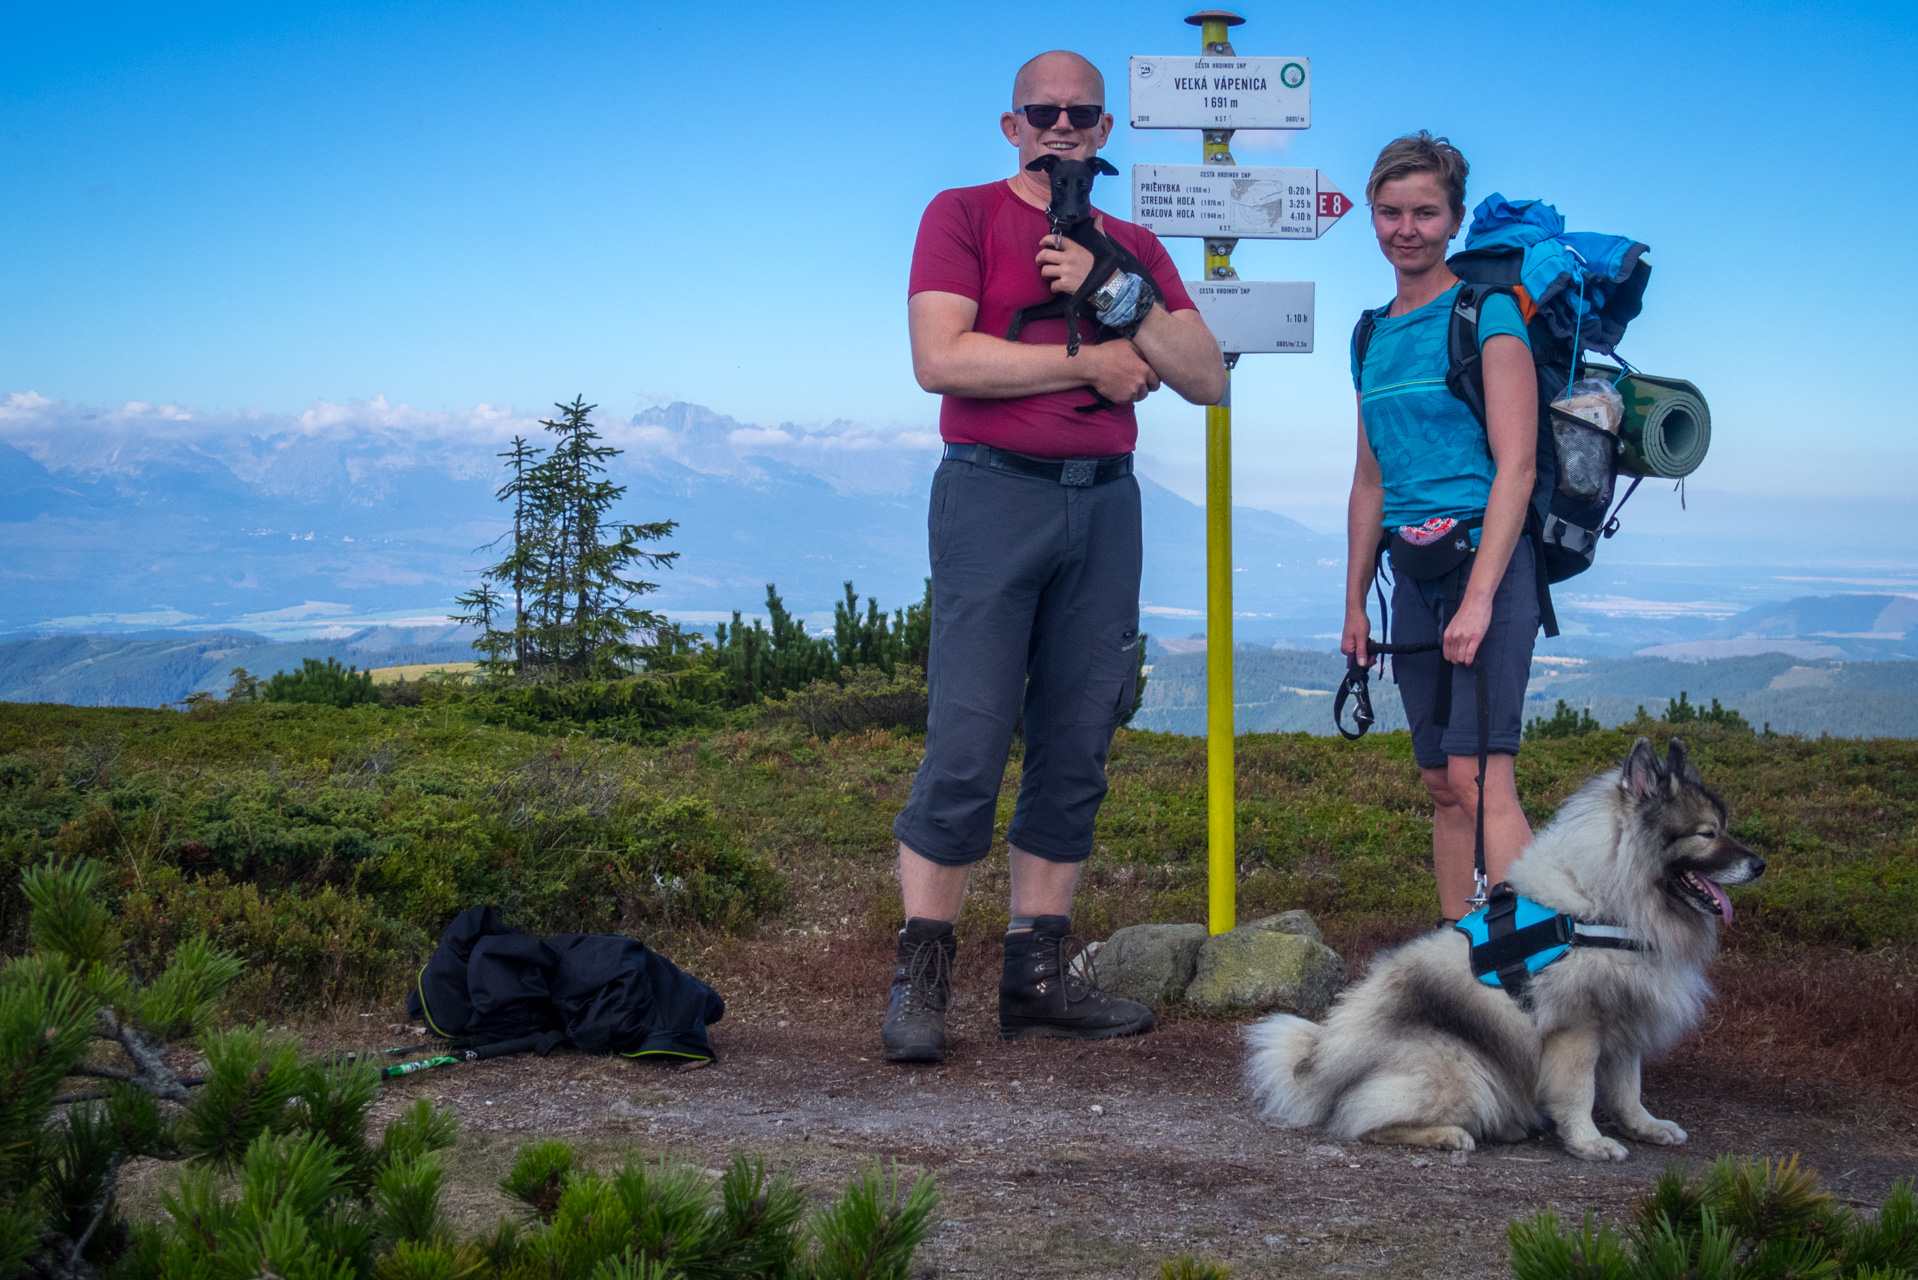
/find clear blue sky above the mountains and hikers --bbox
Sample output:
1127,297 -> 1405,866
0,2 -> 1918,529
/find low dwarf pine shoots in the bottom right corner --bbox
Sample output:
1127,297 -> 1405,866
1506,1155 -> 1918,1280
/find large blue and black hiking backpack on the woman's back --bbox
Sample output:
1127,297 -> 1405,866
1352,192 -> 1651,635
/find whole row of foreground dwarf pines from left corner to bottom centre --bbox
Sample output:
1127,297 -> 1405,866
0,860 -> 934,1280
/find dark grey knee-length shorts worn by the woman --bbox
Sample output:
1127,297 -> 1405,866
1392,537 -> 1538,770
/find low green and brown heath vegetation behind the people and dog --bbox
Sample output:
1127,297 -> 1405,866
0,687 -> 1918,1013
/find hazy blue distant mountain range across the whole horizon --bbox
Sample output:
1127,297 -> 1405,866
0,393 -> 1918,660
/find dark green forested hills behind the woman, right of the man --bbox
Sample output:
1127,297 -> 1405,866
1132,649 -> 1918,737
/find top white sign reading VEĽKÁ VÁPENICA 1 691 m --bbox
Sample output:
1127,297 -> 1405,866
1130,54 -> 1312,129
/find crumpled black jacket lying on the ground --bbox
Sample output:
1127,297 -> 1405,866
407,906 -> 725,1059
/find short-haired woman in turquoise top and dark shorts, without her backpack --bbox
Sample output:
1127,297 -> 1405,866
1341,130 -> 1538,923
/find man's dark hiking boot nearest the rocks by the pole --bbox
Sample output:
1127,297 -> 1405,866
999,915 -> 1153,1040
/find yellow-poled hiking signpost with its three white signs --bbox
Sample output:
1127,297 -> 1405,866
1130,10 -> 1352,933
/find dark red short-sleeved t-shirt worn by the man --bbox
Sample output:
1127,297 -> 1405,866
907,180 -> 1195,459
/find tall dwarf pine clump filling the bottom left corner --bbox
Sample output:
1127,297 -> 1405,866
0,860 -> 453,1280
